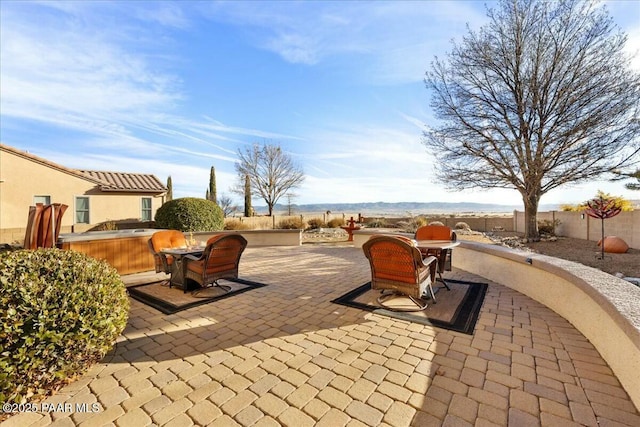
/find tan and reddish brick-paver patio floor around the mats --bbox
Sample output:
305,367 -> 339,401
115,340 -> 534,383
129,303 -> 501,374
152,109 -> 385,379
3,245 -> 640,427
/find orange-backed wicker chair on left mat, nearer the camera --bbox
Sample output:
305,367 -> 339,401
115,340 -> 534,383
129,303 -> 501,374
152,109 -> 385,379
183,233 -> 247,292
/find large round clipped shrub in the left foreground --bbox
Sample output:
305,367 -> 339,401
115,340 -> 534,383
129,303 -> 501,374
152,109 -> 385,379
0,249 -> 129,403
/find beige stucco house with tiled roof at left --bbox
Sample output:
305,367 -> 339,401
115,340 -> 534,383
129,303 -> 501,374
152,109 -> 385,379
0,144 -> 167,243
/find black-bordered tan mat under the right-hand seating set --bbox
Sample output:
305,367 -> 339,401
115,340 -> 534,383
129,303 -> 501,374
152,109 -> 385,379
331,279 -> 488,335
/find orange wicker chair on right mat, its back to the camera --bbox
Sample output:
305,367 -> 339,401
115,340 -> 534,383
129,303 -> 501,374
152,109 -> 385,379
362,236 -> 437,311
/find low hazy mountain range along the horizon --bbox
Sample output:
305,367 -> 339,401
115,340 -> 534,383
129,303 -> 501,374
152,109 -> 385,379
254,202 -> 559,215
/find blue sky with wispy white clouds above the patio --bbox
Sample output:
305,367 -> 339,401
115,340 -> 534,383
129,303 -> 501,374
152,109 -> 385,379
0,0 -> 640,209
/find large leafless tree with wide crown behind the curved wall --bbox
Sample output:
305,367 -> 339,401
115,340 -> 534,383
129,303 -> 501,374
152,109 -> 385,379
424,0 -> 640,240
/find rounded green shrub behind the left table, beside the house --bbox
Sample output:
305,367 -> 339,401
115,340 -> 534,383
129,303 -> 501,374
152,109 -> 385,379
155,197 -> 224,231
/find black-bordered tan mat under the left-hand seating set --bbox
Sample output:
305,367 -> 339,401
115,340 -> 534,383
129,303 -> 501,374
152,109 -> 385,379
127,279 -> 267,314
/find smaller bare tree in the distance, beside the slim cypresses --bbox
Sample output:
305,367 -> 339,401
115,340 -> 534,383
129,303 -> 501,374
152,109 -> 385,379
236,144 -> 304,216
